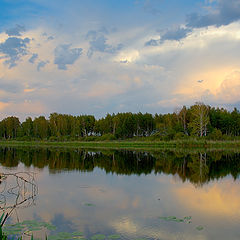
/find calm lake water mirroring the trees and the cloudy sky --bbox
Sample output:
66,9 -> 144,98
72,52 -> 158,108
0,148 -> 240,240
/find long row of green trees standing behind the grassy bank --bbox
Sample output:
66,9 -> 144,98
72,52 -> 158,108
0,102 -> 240,141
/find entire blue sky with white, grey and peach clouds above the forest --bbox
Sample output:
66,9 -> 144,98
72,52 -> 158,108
0,0 -> 240,120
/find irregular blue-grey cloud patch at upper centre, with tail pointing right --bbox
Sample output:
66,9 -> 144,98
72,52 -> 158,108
86,28 -> 123,58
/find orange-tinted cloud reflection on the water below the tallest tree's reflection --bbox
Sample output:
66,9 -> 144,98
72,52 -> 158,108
173,179 -> 240,217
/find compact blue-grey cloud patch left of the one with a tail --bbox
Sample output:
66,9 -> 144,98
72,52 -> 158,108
54,44 -> 82,70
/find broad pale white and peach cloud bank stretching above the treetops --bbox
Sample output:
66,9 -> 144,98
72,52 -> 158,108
0,20 -> 240,119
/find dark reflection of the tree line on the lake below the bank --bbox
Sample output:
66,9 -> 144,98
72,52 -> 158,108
0,148 -> 240,186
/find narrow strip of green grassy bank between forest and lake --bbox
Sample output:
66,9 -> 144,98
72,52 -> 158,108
0,140 -> 240,149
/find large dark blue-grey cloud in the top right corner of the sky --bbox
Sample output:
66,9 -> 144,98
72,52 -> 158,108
186,0 -> 240,28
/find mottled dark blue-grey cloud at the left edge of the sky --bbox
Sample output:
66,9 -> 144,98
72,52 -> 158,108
0,37 -> 30,68
